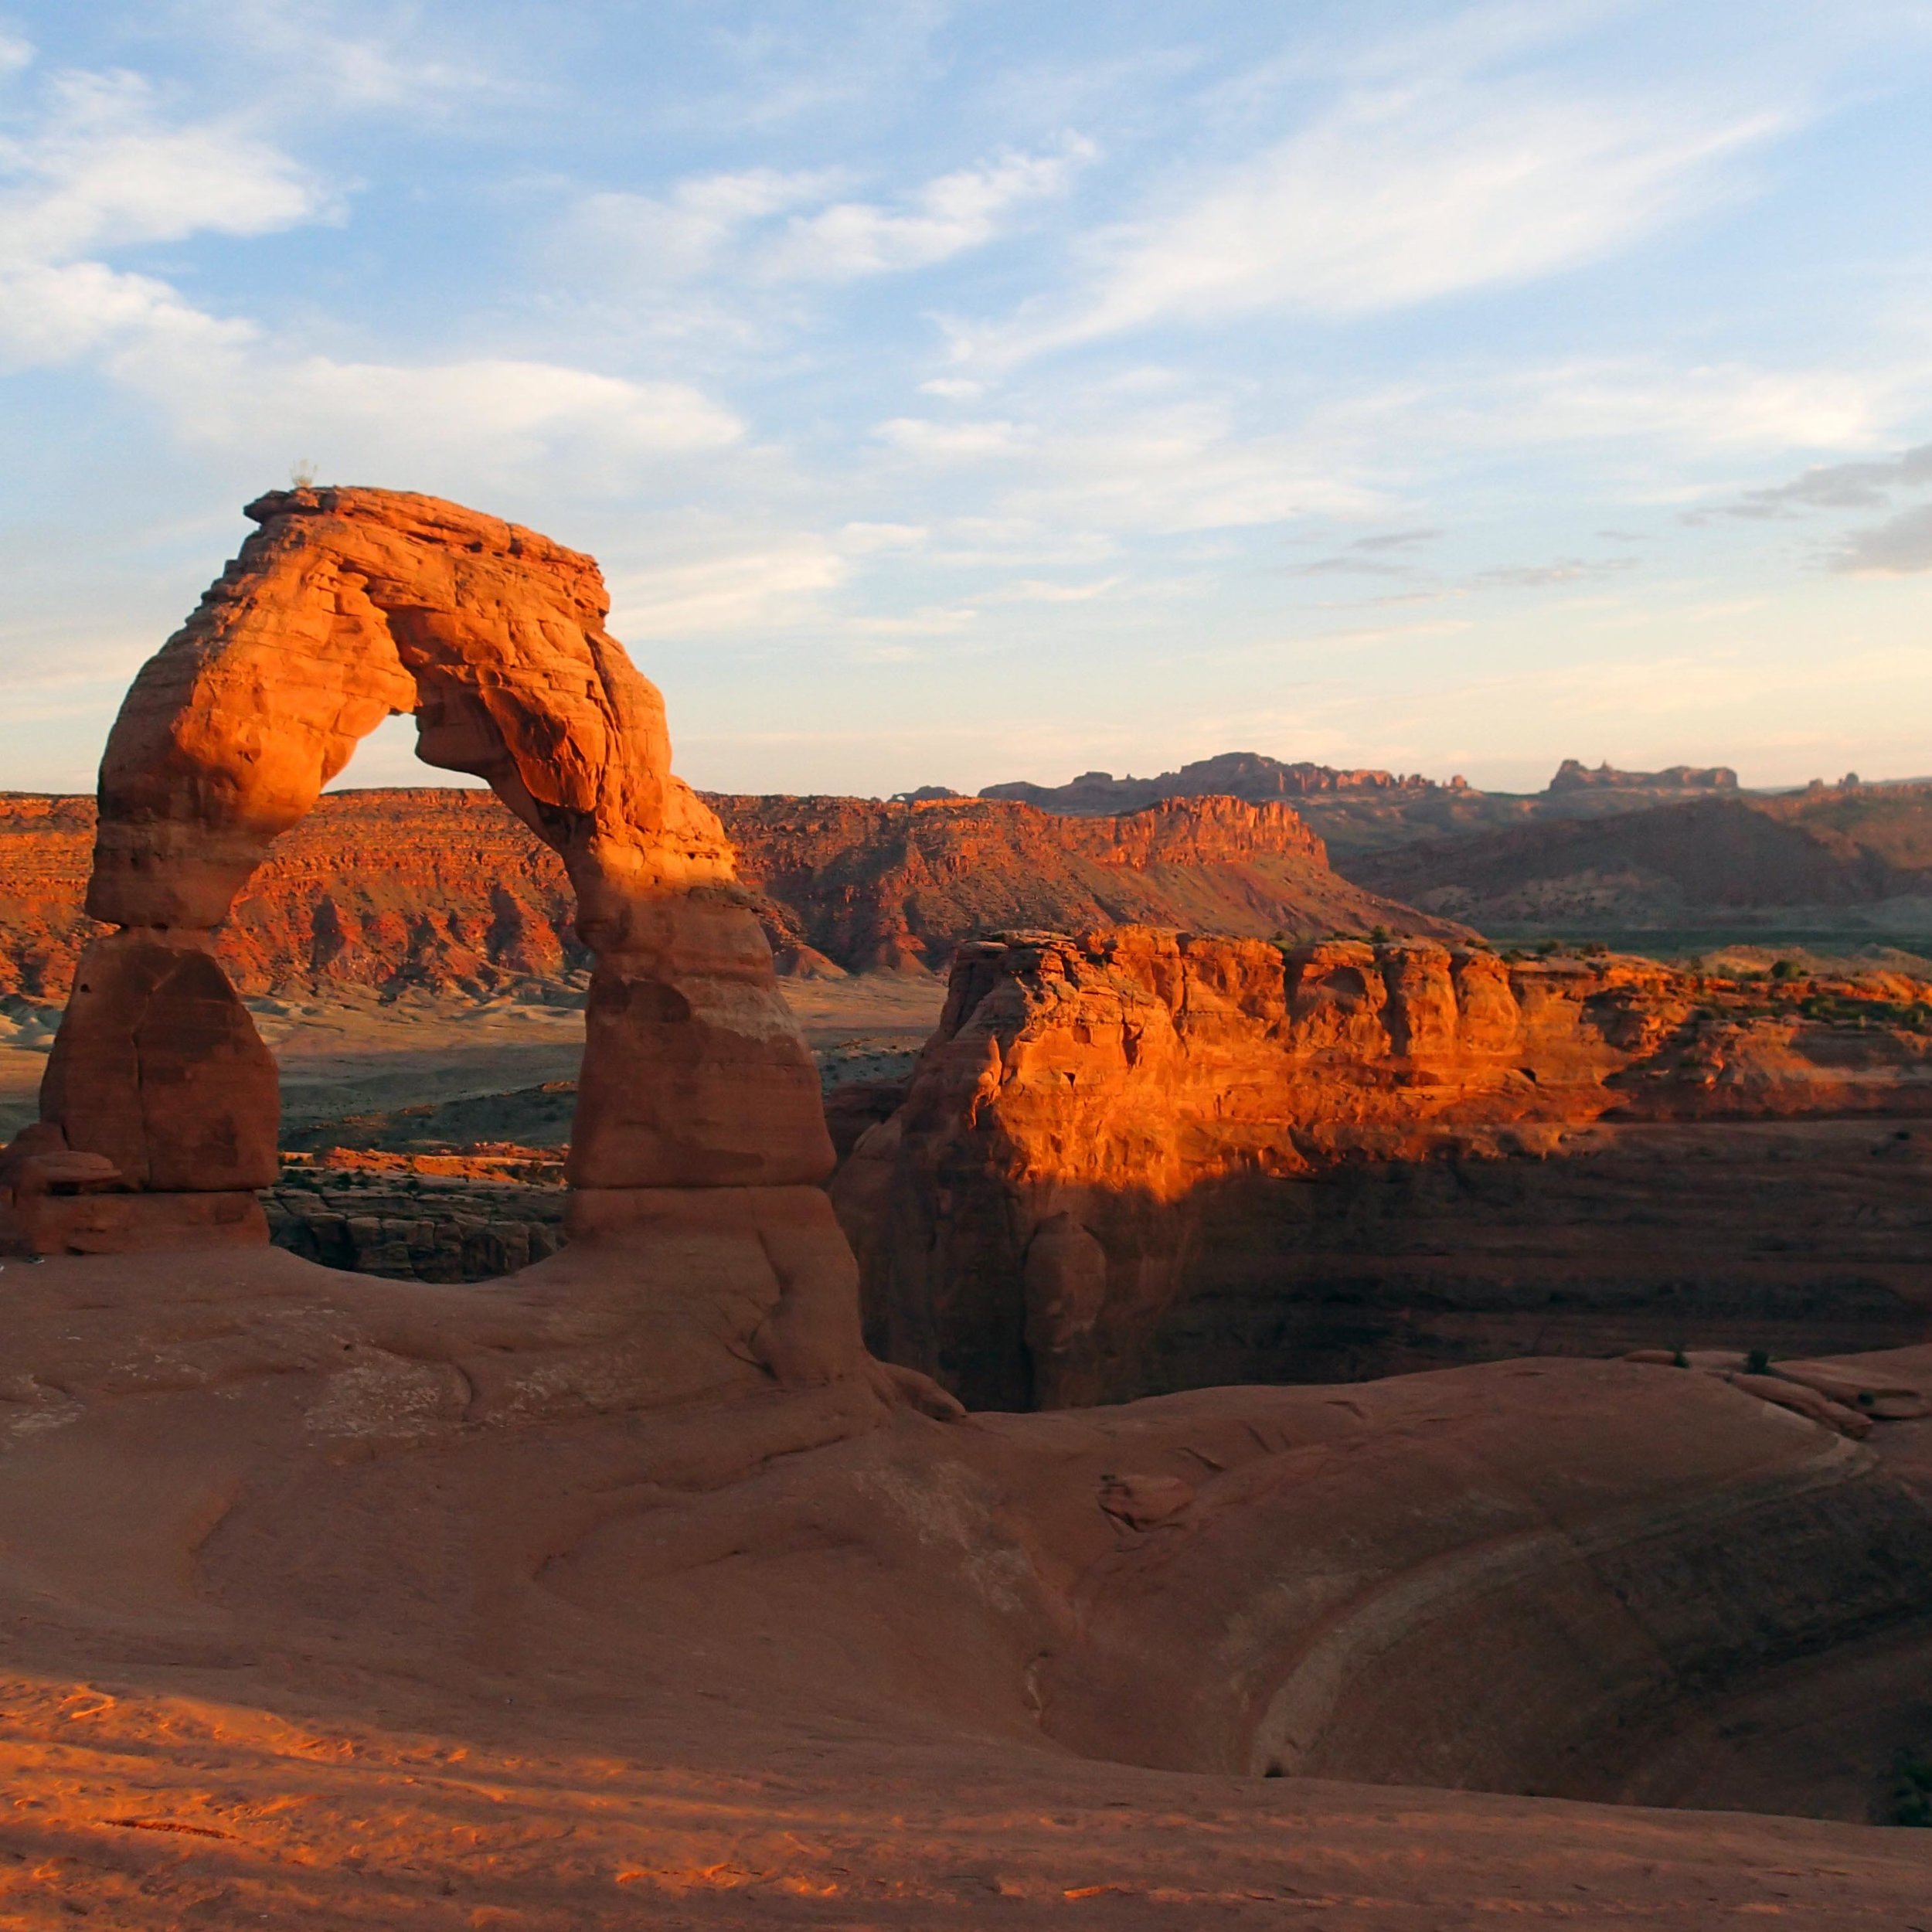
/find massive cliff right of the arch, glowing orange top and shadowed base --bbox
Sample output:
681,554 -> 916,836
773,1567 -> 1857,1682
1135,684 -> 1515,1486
835,931 -> 1932,1406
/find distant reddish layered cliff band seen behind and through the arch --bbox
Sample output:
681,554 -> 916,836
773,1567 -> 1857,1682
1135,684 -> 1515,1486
0,787 -> 1459,1001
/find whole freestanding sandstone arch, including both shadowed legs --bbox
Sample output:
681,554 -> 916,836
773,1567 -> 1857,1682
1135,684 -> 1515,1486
8,489 -> 877,1376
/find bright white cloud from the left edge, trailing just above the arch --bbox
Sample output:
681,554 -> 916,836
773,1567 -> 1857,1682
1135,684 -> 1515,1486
0,54 -> 744,483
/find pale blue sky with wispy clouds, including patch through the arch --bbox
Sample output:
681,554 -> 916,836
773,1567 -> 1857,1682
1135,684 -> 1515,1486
0,0 -> 1932,794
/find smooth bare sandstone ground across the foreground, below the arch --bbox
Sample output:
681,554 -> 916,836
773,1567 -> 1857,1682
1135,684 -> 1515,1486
0,1244 -> 1932,1932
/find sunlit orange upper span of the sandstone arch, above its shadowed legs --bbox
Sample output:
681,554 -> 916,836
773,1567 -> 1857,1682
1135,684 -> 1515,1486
87,489 -> 733,949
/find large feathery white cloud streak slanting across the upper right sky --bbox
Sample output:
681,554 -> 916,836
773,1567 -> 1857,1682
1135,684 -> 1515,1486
962,80 -> 1793,363
